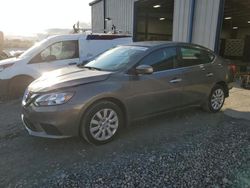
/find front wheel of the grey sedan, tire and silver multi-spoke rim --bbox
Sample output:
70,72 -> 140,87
80,101 -> 124,145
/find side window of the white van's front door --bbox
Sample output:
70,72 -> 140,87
32,41 -> 79,63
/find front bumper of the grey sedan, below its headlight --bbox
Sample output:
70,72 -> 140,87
22,104 -> 80,139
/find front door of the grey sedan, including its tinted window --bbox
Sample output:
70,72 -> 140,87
128,47 -> 182,117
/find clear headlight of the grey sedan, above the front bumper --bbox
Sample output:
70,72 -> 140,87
34,92 -> 74,106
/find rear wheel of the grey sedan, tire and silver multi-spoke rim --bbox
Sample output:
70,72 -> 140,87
203,85 -> 226,113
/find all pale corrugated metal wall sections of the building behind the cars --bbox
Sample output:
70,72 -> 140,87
89,0 -> 220,50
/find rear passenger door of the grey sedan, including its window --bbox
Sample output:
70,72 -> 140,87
179,46 -> 215,105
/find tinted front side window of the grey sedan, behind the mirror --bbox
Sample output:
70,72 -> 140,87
140,48 -> 177,72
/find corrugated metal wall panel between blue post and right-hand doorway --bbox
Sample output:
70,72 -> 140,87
193,0 -> 220,50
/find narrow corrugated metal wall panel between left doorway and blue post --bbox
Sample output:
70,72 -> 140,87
173,0 -> 191,42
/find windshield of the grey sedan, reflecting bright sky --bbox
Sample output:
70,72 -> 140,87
84,46 -> 148,71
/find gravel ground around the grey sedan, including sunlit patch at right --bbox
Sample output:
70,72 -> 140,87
0,88 -> 250,188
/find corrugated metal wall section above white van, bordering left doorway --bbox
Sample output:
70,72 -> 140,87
106,0 -> 135,34
